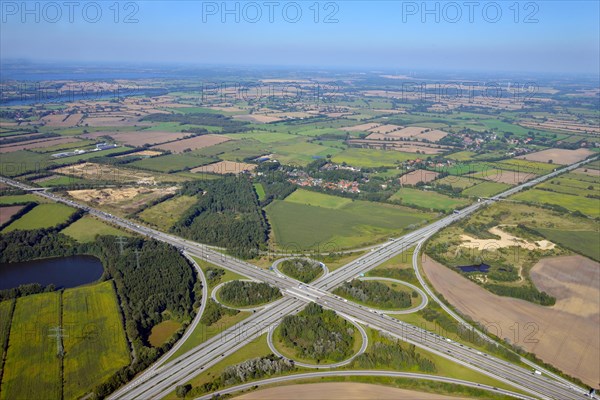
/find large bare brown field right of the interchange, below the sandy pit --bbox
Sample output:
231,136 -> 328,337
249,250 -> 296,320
423,256 -> 600,387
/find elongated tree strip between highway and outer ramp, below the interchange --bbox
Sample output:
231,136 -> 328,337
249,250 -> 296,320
183,354 -> 296,397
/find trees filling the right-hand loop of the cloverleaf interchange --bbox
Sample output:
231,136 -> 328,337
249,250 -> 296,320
334,279 -> 411,309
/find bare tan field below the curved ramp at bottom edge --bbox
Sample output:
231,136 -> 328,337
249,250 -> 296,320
236,382 -> 456,400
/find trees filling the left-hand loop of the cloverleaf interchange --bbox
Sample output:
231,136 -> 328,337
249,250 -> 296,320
219,281 -> 281,307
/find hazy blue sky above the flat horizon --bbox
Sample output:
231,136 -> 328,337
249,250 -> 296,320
0,0 -> 600,73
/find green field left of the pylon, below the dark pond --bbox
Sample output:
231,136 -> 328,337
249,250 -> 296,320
0,292 -> 61,400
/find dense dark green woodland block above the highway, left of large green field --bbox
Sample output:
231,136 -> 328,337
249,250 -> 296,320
173,177 -> 269,258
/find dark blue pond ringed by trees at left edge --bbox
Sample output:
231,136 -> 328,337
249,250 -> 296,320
0,255 -> 104,289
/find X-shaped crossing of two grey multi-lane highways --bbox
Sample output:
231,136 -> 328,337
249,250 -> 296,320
0,156 -> 591,400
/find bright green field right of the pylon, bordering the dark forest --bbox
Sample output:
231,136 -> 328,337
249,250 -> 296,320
62,282 -> 129,399
